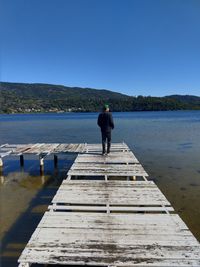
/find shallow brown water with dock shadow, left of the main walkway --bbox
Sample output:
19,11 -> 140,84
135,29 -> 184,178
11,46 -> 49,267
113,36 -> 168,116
0,156 -> 73,267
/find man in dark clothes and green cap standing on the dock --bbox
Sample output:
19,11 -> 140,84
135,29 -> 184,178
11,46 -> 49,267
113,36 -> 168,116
97,105 -> 114,155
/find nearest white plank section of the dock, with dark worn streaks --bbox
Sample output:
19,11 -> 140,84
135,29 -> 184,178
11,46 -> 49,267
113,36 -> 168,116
19,212 -> 200,266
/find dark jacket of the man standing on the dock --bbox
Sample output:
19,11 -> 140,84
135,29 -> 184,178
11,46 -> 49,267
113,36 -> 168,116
97,111 -> 114,133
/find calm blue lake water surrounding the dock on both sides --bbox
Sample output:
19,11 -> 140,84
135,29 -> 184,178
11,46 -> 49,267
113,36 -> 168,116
0,111 -> 200,267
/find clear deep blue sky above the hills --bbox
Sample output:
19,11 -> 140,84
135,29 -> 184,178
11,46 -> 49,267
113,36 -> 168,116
0,0 -> 200,96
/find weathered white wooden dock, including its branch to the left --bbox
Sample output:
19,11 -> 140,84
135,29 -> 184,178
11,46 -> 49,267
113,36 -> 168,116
2,143 -> 200,267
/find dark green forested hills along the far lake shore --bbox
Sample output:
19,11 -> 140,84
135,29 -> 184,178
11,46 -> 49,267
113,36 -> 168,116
0,82 -> 200,113
